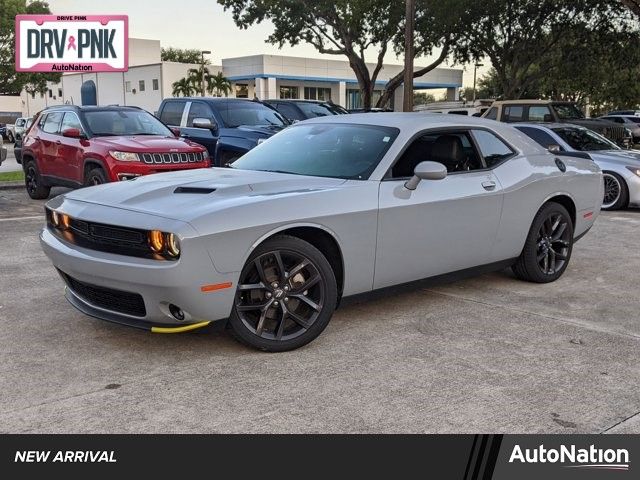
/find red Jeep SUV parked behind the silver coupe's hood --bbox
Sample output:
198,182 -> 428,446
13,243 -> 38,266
22,105 -> 210,199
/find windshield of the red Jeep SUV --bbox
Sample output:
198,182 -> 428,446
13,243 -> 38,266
84,110 -> 173,137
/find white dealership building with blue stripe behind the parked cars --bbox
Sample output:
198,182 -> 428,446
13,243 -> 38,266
17,38 -> 463,116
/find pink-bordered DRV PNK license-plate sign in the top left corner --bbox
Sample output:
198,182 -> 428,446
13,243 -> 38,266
16,15 -> 129,72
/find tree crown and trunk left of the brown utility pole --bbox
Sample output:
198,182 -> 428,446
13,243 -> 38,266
218,0 -> 404,108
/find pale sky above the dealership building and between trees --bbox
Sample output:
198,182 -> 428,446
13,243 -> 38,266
48,0 -> 488,86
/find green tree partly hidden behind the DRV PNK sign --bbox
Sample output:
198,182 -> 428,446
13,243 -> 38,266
0,0 -> 61,95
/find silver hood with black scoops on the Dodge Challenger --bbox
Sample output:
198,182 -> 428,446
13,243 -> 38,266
65,168 -> 346,222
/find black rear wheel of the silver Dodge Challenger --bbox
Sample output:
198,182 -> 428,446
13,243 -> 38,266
512,202 -> 573,283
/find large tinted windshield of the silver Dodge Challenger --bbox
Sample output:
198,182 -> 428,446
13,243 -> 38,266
231,123 -> 400,180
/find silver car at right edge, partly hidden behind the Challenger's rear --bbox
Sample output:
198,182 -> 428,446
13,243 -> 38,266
514,123 -> 640,210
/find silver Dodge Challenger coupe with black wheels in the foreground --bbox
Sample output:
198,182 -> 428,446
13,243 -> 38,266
40,113 -> 603,351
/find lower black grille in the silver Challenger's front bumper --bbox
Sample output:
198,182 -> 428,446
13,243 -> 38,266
60,272 -> 147,317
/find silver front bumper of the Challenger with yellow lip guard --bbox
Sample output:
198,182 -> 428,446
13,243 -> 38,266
40,219 -> 239,333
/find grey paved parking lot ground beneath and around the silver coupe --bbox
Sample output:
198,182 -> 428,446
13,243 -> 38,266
0,190 -> 640,433
